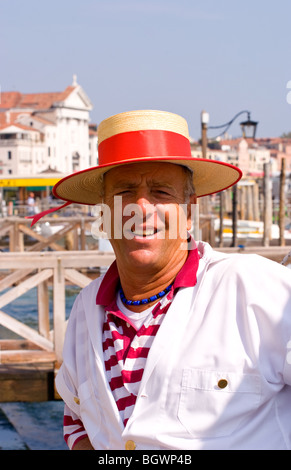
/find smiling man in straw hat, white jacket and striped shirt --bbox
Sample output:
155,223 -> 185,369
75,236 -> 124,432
34,111 -> 291,450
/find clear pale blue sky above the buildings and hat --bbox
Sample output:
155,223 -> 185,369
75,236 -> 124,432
0,0 -> 291,139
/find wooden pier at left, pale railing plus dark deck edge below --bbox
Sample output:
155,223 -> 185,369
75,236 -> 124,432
0,250 -> 114,402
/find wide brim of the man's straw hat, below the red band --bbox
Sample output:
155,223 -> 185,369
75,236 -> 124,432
53,157 -> 242,205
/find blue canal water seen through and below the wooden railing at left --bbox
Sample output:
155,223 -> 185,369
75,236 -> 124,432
0,286 -> 80,450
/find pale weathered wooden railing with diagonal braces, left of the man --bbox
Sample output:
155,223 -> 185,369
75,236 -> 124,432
0,250 -> 114,364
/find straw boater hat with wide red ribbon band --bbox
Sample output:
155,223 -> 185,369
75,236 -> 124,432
53,110 -> 242,204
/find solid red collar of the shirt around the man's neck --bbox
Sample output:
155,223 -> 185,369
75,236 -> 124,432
96,241 -> 199,307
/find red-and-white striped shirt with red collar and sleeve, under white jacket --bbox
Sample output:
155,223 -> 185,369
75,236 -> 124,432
64,249 -> 199,449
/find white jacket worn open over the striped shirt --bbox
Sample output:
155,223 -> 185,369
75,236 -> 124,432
56,242 -> 291,450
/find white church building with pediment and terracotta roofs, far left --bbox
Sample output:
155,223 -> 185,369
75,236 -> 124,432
0,77 -> 98,176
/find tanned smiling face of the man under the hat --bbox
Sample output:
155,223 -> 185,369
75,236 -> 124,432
104,162 -> 196,272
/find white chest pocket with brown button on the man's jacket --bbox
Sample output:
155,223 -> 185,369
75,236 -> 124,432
178,369 -> 261,438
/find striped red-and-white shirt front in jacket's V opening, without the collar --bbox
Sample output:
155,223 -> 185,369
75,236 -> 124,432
103,292 -> 173,425
